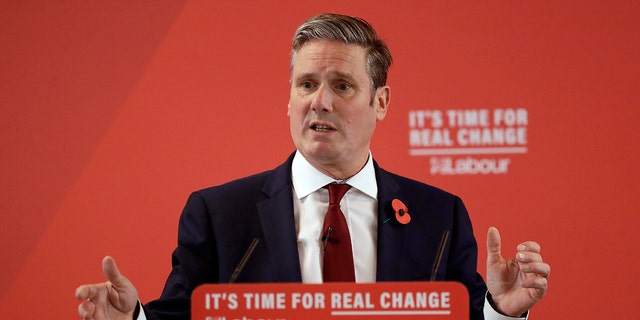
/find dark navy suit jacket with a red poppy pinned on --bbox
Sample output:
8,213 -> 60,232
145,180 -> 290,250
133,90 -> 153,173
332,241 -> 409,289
144,155 -> 486,320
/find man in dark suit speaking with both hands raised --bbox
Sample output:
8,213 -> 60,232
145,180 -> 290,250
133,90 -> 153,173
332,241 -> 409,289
76,14 -> 550,320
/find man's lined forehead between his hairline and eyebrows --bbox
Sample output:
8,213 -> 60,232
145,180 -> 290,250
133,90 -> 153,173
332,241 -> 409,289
292,40 -> 366,75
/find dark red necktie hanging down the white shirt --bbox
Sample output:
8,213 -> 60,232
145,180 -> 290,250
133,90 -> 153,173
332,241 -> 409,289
322,183 -> 356,282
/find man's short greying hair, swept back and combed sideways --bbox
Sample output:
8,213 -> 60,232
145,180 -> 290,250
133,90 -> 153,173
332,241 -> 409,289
291,13 -> 392,92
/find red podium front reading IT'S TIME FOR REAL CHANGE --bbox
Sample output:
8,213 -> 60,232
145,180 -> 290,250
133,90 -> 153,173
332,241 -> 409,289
191,282 -> 469,320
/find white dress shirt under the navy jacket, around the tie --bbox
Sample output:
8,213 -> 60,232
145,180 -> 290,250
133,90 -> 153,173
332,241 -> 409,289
291,152 -> 378,283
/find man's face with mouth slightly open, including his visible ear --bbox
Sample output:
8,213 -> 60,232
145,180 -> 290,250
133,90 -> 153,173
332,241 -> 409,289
288,40 -> 389,178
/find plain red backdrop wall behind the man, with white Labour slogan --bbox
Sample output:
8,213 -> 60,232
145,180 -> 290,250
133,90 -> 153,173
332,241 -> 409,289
0,0 -> 640,319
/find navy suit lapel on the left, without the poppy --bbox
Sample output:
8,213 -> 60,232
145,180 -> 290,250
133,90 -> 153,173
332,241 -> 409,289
257,155 -> 302,282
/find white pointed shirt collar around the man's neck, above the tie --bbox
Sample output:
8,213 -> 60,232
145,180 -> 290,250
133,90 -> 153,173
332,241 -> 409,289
291,151 -> 378,199
